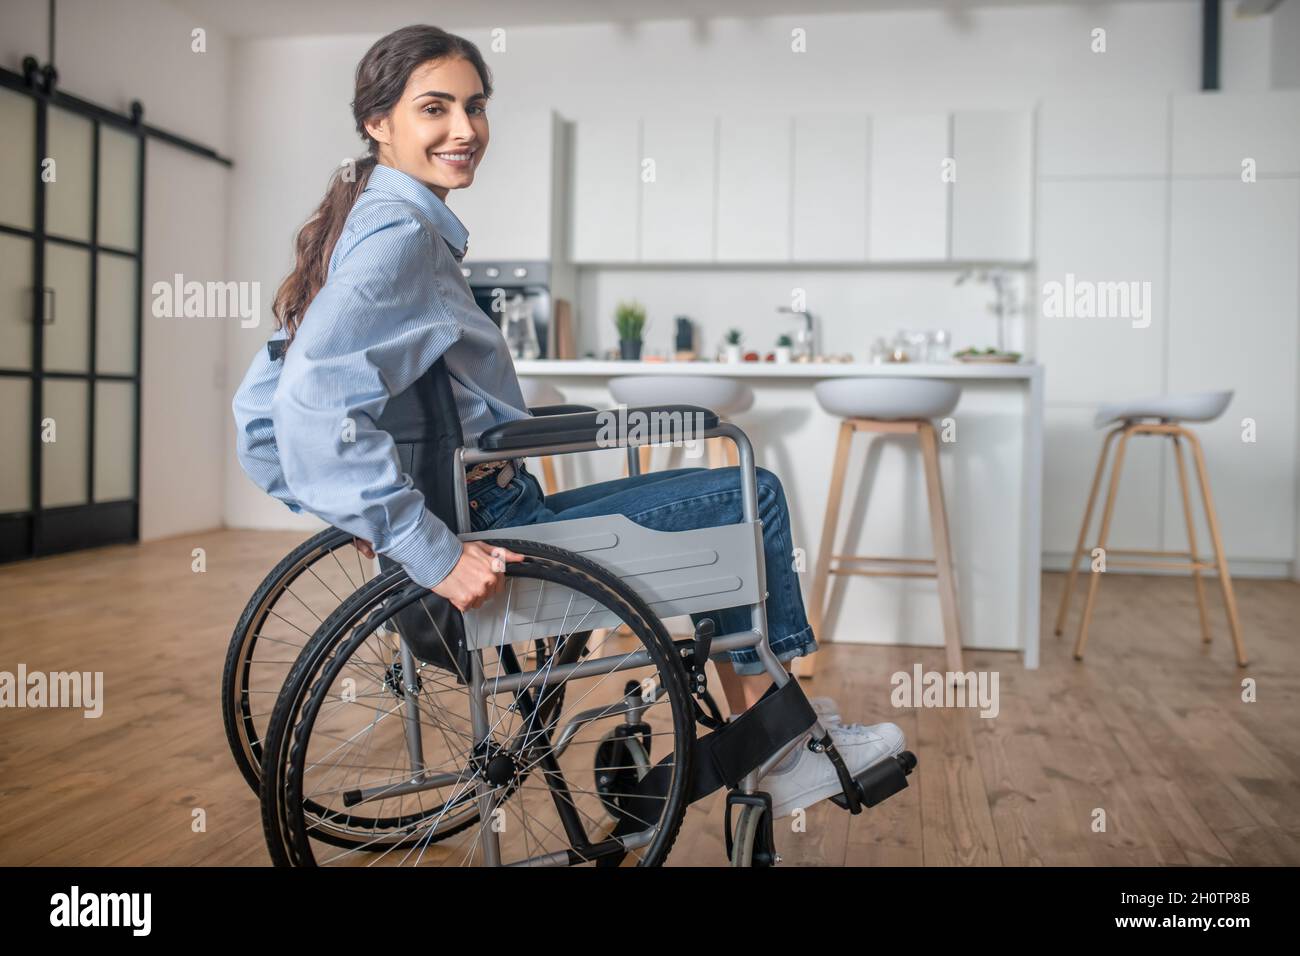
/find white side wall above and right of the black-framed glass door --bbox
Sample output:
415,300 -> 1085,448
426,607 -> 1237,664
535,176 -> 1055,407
0,0 -> 230,540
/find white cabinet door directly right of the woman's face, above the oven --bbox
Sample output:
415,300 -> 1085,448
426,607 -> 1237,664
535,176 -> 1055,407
447,111 -> 564,261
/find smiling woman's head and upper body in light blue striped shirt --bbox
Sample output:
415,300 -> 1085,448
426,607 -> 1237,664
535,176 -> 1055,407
234,25 -> 528,609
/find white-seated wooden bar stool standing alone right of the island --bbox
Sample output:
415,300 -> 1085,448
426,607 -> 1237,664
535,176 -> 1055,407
1056,392 -> 1247,667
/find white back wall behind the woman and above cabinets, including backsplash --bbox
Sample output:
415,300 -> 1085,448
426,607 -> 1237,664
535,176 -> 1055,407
202,0 -> 1270,527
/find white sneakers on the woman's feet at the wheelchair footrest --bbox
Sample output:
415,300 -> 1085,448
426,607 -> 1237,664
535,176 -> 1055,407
758,723 -> 905,819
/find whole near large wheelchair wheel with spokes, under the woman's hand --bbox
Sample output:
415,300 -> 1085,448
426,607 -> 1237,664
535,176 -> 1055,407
261,540 -> 694,866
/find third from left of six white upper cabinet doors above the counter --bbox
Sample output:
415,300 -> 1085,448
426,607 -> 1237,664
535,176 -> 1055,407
716,113 -> 793,263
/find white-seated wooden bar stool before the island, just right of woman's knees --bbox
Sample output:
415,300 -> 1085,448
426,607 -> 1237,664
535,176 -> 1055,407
796,377 -> 962,676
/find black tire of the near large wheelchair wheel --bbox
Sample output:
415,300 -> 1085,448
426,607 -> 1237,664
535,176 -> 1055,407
261,540 -> 694,866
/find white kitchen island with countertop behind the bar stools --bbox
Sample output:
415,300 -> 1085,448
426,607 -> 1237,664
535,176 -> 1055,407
515,360 -> 1045,669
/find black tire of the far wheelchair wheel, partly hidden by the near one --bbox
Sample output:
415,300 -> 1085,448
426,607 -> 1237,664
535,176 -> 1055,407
221,528 -> 369,793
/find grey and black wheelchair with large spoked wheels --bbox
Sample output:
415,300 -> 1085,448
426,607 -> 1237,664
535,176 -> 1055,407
241,360 -> 917,866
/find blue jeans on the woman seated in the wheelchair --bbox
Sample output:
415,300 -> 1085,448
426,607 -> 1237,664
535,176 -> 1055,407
468,467 -> 816,674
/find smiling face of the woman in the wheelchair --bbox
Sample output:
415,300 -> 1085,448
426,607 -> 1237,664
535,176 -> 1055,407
365,57 -> 489,200
